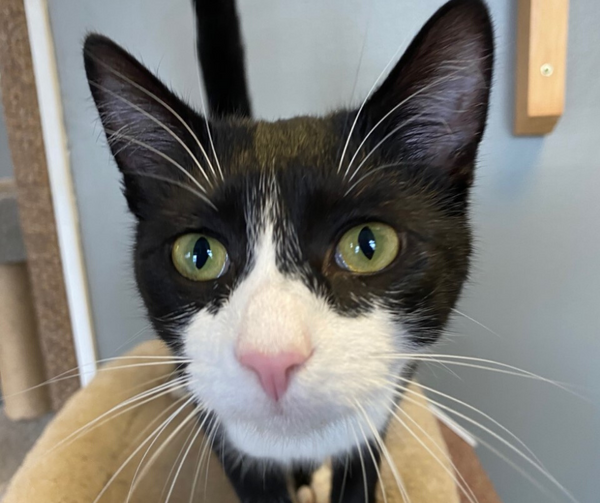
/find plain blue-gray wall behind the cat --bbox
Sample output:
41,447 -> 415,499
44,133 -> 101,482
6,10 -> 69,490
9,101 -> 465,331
50,0 -> 600,503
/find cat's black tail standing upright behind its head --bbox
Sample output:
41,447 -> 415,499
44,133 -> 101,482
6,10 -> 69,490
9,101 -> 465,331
192,0 -> 251,117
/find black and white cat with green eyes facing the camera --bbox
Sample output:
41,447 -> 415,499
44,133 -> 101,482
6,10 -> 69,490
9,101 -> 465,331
84,0 -> 494,503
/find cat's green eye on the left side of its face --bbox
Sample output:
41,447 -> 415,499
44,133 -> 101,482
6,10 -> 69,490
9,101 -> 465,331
171,234 -> 229,281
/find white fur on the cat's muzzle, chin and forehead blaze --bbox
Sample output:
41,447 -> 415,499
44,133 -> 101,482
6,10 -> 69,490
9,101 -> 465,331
184,201 -> 408,464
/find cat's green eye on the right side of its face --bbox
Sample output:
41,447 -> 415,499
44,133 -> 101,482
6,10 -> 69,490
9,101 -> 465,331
335,222 -> 400,274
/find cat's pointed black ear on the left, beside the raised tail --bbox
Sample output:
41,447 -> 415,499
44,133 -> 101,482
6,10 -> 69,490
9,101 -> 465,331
84,34 -> 212,218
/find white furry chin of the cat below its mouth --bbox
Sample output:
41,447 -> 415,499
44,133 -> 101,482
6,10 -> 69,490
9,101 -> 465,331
223,411 -> 388,465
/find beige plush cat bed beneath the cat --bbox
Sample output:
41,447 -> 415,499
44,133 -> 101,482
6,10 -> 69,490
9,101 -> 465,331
3,342 -> 499,503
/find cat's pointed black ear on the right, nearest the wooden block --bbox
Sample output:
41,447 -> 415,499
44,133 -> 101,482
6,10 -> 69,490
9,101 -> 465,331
365,0 -> 494,187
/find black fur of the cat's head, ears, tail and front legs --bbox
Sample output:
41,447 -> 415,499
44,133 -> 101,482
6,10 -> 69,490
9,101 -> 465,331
85,0 -> 493,503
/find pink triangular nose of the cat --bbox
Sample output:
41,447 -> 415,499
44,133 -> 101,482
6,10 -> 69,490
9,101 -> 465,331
239,351 -> 308,401
